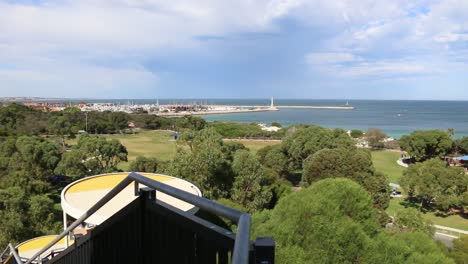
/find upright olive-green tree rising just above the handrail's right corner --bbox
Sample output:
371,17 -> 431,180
232,150 -> 272,212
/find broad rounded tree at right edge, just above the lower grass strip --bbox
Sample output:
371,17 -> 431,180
401,159 -> 468,211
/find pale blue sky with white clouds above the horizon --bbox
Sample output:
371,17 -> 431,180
0,0 -> 468,100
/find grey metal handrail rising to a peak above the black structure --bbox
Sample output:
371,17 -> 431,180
24,172 -> 251,264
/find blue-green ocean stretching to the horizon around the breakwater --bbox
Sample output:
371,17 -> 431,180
31,98 -> 468,138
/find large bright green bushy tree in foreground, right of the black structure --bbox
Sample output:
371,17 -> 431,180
252,179 -> 453,264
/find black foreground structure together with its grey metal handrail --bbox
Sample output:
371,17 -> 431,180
1,173 -> 275,264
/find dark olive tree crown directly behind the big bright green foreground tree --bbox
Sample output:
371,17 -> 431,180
302,148 -> 390,209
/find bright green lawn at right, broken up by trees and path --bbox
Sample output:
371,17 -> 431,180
372,151 -> 468,230
